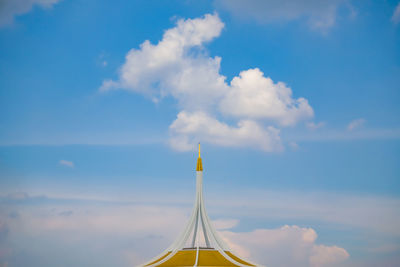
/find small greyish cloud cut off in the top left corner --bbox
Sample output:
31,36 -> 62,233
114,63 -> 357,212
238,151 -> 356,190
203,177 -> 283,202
0,0 -> 60,27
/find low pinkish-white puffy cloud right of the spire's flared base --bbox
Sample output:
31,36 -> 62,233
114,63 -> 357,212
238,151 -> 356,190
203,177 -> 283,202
222,225 -> 349,267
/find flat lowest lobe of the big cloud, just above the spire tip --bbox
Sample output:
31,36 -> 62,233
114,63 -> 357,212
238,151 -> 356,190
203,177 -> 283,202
170,111 -> 282,151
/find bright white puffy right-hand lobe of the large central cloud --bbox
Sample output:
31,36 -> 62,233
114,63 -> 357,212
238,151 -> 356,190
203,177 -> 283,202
221,68 -> 314,126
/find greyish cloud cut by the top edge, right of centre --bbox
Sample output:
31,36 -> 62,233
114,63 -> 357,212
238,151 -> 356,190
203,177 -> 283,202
215,0 -> 354,31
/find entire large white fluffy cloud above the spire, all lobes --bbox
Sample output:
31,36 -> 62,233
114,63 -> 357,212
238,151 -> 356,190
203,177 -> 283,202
100,14 -> 313,151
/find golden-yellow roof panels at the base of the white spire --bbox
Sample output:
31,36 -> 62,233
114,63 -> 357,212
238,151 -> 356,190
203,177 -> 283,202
146,249 -> 254,267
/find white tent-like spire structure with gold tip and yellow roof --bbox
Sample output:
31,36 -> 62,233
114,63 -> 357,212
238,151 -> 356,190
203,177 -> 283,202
142,144 -> 259,267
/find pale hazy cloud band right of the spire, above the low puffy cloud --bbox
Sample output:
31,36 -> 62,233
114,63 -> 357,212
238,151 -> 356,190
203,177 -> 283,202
210,191 -> 400,237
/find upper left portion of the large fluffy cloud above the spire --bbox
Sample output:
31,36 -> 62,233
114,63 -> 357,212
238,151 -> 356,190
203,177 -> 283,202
100,14 -> 227,109
